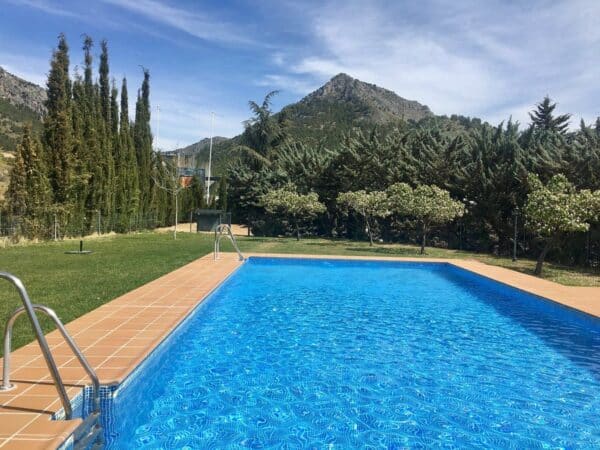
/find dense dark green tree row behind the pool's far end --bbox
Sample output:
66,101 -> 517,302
227,93 -> 600,272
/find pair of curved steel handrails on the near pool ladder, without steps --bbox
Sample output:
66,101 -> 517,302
0,271 -> 100,420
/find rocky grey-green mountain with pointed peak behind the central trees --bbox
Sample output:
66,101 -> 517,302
176,73 -> 433,168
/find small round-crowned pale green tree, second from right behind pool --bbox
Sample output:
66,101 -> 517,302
387,183 -> 465,254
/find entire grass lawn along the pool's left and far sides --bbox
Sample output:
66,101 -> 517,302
0,232 -> 600,354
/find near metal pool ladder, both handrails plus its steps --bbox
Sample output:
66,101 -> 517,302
0,272 -> 104,449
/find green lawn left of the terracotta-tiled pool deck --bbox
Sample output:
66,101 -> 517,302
0,233 -> 212,354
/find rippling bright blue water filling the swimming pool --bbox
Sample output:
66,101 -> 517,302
104,258 -> 600,449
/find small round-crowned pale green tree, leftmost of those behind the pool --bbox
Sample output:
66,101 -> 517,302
261,185 -> 325,241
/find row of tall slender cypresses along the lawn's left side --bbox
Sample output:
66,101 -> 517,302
4,34 -> 211,238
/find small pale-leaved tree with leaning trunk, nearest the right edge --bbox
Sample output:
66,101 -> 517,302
524,174 -> 600,276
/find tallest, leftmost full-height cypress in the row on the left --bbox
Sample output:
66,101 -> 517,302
44,34 -> 73,204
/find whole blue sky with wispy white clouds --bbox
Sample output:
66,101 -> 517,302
0,0 -> 600,149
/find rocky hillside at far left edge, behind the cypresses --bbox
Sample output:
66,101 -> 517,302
0,67 -> 46,150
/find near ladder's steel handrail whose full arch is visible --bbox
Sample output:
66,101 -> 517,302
0,304 -> 100,413
